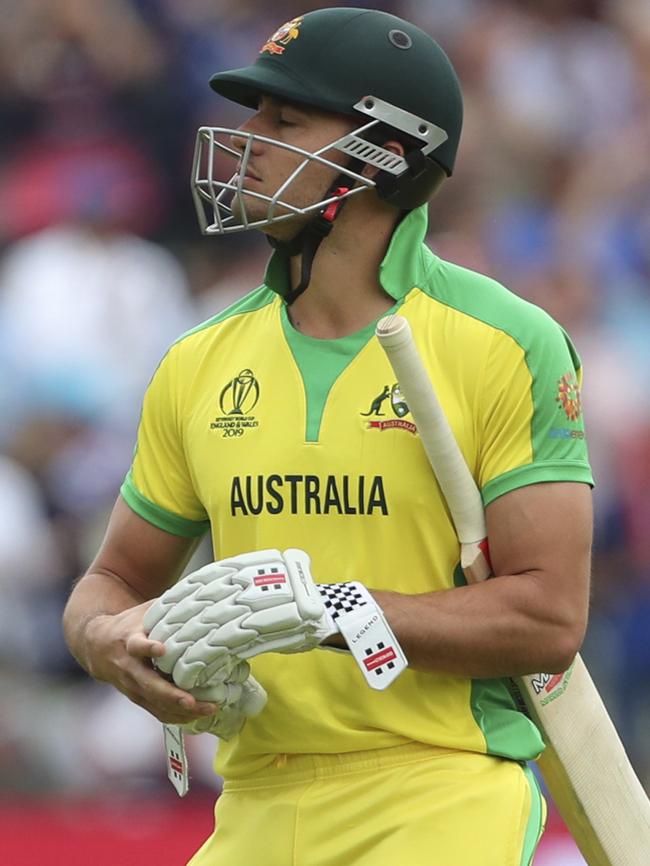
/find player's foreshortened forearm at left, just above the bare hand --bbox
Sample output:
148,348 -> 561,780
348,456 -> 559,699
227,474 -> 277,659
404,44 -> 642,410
63,572 -> 145,675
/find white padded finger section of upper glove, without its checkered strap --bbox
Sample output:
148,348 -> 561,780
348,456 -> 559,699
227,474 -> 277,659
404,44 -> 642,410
144,550 -> 335,689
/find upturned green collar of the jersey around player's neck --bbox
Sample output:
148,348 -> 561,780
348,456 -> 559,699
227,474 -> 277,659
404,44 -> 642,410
264,204 -> 428,301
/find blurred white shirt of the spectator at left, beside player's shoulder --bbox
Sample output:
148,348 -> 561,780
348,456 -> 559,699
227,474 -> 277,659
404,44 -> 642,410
0,191 -> 196,432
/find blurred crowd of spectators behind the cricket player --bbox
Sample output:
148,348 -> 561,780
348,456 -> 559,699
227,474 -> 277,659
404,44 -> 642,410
0,0 -> 650,836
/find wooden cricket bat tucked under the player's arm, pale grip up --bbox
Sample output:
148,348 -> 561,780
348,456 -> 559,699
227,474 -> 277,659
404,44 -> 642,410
376,315 -> 650,866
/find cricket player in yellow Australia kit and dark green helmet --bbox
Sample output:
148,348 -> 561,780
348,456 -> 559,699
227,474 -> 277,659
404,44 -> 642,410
64,8 -> 592,866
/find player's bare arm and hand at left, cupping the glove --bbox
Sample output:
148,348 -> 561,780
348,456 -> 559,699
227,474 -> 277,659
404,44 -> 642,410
63,497 -> 217,724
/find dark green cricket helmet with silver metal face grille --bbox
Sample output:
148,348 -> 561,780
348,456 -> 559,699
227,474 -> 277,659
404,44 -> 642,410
193,8 -> 463,240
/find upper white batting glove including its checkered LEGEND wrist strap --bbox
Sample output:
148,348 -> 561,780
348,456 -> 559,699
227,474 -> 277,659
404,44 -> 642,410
145,549 -> 407,689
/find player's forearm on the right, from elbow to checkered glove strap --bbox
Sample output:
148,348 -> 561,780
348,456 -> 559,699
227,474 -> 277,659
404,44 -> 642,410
373,574 -> 586,678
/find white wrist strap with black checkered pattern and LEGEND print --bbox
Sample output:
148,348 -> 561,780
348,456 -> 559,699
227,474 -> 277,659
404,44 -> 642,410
317,581 -> 408,690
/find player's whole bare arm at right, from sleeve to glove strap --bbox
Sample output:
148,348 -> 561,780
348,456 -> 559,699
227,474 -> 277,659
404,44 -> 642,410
373,482 -> 592,677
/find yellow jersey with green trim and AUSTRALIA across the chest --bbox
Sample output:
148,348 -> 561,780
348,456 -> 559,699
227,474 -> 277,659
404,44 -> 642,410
122,207 -> 592,777
